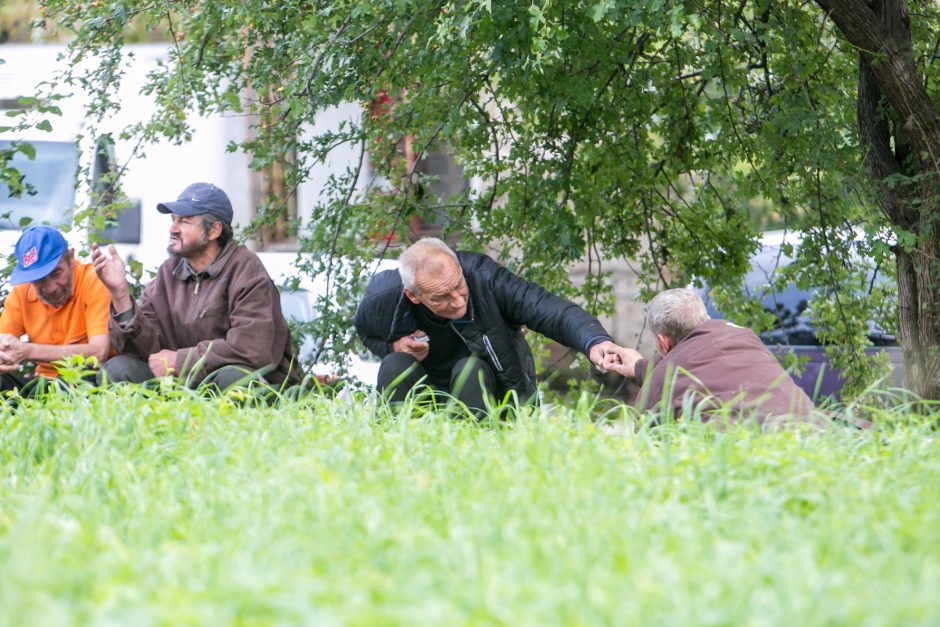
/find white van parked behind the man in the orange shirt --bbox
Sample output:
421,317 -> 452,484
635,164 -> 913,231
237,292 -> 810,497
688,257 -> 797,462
0,45 -> 142,274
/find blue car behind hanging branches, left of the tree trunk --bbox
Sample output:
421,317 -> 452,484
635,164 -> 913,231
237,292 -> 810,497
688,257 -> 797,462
702,231 -> 904,400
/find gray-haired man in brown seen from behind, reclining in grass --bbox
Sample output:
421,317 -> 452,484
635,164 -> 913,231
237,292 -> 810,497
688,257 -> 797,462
604,289 -> 815,422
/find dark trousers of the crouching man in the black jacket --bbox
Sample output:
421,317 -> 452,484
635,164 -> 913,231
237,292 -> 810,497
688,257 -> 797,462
376,353 -> 497,417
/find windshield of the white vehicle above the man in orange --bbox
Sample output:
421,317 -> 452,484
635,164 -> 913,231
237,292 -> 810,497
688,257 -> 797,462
0,140 -> 78,229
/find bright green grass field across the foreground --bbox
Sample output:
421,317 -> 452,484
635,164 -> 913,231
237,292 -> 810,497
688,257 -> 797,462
0,391 -> 940,626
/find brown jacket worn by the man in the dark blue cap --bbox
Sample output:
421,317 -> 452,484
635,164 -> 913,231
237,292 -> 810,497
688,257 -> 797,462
109,242 -> 300,385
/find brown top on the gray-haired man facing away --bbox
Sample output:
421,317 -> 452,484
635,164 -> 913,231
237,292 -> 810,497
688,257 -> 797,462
634,320 -> 815,422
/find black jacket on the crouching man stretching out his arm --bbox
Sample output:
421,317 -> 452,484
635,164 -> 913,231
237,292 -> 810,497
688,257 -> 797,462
354,252 -> 612,400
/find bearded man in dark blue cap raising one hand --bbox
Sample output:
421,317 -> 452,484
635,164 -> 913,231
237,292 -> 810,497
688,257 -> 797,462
92,183 -> 301,389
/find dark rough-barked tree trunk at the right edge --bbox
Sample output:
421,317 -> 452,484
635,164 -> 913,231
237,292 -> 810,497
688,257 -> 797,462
817,0 -> 940,399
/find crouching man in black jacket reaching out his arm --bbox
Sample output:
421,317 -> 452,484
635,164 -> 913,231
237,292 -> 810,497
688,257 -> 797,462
355,238 -> 619,414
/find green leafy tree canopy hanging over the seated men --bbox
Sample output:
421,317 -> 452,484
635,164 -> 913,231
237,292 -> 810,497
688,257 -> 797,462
23,0 -> 938,392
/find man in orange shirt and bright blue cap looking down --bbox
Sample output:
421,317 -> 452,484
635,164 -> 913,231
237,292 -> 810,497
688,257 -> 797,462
0,226 -> 112,390
